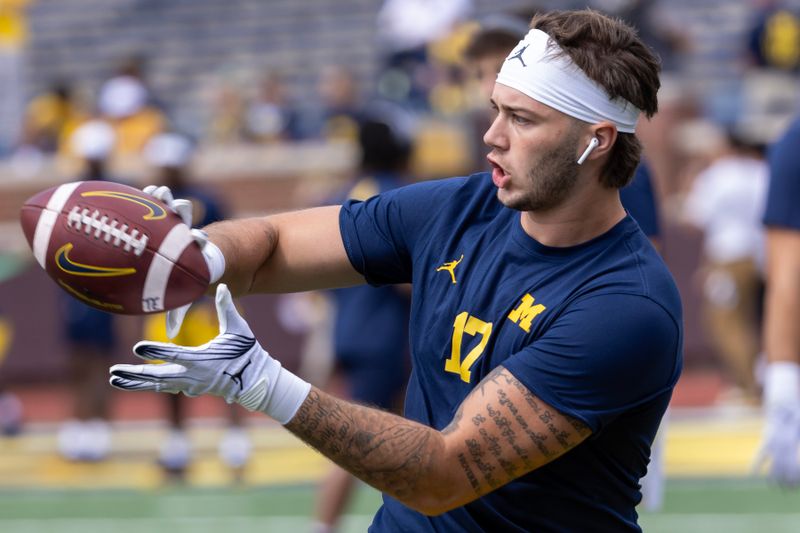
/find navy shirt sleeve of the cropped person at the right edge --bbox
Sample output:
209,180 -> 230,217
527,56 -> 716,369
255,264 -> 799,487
764,119 -> 800,230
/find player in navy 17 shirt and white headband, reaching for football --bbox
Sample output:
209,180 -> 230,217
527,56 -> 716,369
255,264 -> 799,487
111,11 -> 682,531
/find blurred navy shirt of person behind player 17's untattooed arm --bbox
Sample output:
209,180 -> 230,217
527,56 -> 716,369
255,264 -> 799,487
331,173 -> 411,409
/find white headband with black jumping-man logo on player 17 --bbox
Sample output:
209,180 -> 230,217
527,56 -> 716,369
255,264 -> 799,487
497,30 -> 641,133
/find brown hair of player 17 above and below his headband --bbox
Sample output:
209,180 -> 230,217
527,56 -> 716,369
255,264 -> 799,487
530,9 -> 661,188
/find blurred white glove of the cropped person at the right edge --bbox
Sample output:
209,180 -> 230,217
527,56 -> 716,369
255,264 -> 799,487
755,361 -> 800,486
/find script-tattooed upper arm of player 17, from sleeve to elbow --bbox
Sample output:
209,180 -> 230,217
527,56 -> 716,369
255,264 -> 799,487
442,366 -> 591,507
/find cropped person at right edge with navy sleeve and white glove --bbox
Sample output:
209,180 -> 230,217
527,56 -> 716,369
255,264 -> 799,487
756,119 -> 800,487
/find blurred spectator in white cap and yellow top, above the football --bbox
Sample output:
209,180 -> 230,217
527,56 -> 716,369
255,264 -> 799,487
97,57 -> 166,157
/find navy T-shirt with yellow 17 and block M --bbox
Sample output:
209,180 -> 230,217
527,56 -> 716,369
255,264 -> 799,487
340,173 -> 682,532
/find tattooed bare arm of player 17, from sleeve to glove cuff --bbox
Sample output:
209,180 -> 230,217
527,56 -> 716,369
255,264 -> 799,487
286,367 -> 591,515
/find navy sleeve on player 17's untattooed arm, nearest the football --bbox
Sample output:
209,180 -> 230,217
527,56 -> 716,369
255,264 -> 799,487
339,178 -> 463,286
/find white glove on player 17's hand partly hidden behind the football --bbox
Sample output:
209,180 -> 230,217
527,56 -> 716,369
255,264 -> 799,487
142,185 -> 225,339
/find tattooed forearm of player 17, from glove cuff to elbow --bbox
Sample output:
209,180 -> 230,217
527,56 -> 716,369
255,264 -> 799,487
286,388 -> 441,500
